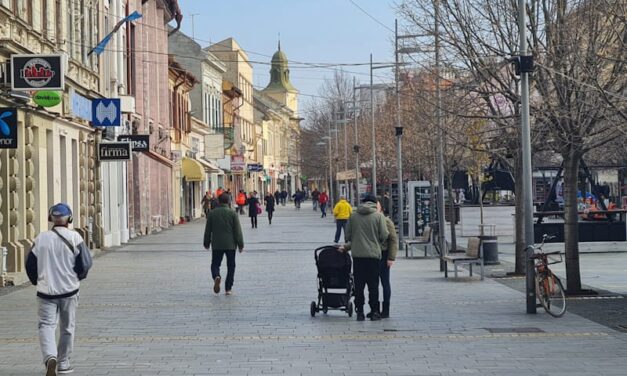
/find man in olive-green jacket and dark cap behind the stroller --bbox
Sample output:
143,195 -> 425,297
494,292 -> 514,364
343,195 -> 389,321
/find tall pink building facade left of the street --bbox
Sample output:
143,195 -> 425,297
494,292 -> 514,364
126,0 -> 181,237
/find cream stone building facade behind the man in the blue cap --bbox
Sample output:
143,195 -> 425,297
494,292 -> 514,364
0,0 -> 102,285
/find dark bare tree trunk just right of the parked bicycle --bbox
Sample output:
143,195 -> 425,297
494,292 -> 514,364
563,151 -> 581,294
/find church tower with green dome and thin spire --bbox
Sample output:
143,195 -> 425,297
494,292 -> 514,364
263,41 -> 298,115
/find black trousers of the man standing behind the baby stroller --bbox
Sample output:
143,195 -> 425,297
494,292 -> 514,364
353,258 -> 380,312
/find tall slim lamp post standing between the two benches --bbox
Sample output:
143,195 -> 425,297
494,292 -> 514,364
433,0 -> 448,269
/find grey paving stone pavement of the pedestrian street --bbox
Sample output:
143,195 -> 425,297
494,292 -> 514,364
0,205 -> 627,376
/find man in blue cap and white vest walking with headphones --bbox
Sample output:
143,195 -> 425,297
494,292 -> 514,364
26,203 -> 92,376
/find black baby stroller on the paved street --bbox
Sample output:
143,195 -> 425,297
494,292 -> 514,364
310,245 -> 353,317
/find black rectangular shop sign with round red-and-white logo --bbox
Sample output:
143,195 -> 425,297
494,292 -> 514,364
11,54 -> 65,90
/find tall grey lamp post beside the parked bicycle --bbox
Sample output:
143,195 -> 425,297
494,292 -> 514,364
518,0 -> 536,313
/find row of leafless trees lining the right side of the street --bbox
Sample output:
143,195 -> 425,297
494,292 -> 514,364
303,0 -> 627,294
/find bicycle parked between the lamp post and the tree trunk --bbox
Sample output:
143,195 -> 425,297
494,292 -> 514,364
531,234 -> 566,317
